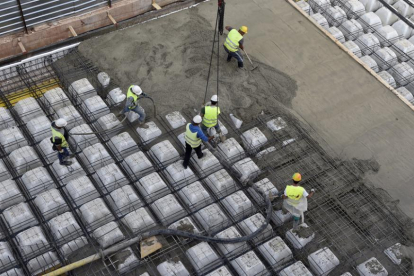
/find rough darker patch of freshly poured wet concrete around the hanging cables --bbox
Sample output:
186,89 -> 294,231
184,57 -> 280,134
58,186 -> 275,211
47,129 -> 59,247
79,7 -> 297,123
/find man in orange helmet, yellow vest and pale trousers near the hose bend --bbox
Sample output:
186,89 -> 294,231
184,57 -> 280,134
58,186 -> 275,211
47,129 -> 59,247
282,173 -> 315,231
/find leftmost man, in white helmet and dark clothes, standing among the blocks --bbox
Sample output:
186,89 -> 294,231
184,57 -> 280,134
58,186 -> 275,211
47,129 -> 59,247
50,118 -> 72,166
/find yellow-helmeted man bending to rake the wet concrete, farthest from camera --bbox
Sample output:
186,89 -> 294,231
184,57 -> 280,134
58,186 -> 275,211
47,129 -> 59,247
224,26 -> 247,68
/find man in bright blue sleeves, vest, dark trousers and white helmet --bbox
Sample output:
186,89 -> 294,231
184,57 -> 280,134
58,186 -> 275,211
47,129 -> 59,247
183,115 -> 213,169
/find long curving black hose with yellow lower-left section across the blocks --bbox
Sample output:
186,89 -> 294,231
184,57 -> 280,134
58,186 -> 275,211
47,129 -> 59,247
44,186 -> 273,276
